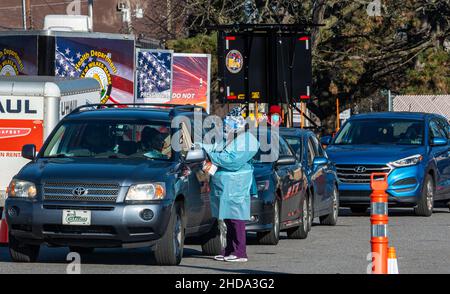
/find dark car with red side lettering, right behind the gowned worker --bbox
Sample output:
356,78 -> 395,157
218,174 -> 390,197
247,131 -> 308,245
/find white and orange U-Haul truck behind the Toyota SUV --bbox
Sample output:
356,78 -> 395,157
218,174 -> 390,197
0,76 -> 101,209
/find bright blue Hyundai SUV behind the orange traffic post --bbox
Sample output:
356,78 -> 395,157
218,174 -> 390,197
321,112 -> 450,216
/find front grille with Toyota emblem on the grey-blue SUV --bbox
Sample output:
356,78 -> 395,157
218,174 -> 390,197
43,182 -> 120,203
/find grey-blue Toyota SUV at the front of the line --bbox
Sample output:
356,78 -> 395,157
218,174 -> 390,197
6,105 -> 221,265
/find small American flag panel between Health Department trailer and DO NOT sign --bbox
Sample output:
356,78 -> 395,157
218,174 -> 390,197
136,49 -> 173,103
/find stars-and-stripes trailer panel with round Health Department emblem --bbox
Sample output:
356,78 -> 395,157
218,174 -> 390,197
55,37 -> 134,103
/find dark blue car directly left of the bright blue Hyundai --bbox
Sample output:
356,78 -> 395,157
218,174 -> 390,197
280,128 -> 339,226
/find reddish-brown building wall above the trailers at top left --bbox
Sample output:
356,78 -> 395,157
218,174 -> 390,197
0,0 -> 185,39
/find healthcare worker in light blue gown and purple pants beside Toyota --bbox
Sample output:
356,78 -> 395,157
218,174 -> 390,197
204,108 -> 259,262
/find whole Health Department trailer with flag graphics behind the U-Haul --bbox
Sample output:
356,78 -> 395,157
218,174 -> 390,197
0,30 -> 136,103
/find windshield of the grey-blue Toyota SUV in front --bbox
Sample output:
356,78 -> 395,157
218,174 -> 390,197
43,120 -> 172,160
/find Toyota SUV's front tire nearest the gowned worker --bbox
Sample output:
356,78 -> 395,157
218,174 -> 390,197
154,202 -> 185,265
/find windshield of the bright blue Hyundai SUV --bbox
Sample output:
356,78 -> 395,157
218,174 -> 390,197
333,119 -> 424,145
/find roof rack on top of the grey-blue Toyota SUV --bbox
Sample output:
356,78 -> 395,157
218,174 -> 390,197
69,103 -> 205,115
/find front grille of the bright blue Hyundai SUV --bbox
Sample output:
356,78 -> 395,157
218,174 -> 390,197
336,164 -> 391,184
